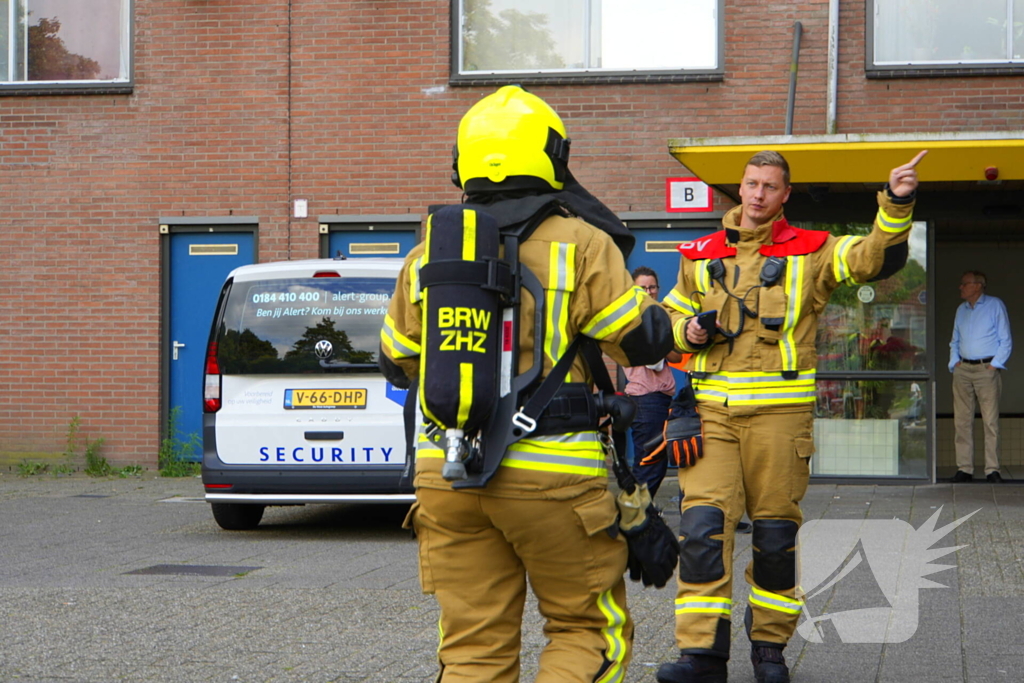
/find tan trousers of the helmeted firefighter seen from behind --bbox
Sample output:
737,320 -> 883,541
410,488 -> 633,683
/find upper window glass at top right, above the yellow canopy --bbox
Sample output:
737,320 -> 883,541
869,0 -> 1024,69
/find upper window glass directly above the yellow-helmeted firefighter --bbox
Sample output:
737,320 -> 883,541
453,0 -> 722,78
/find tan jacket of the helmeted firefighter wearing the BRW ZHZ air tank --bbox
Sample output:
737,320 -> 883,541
381,210 -> 671,499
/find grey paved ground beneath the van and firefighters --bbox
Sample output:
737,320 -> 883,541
0,474 -> 1024,683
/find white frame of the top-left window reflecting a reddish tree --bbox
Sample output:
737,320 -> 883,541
0,0 -> 135,95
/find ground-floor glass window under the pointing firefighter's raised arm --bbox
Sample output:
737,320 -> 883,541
811,222 -> 931,477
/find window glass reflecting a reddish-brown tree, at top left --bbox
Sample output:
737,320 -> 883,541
0,0 -> 131,89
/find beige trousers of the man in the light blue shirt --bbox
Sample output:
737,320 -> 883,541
953,362 -> 1002,475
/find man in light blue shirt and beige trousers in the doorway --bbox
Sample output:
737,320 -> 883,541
949,270 -> 1013,483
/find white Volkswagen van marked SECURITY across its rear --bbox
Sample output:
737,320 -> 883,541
203,258 -> 415,529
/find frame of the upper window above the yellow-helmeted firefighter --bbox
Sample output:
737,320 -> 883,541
450,0 -> 725,85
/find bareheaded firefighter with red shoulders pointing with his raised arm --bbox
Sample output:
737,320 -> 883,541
656,151 -> 927,683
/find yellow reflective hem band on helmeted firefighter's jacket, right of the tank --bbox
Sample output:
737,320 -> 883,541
502,432 -> 608,476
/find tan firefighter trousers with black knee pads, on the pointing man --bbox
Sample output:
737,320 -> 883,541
676,403 -> 814,658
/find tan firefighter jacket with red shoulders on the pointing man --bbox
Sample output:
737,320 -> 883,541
662,190 -> 913,415
